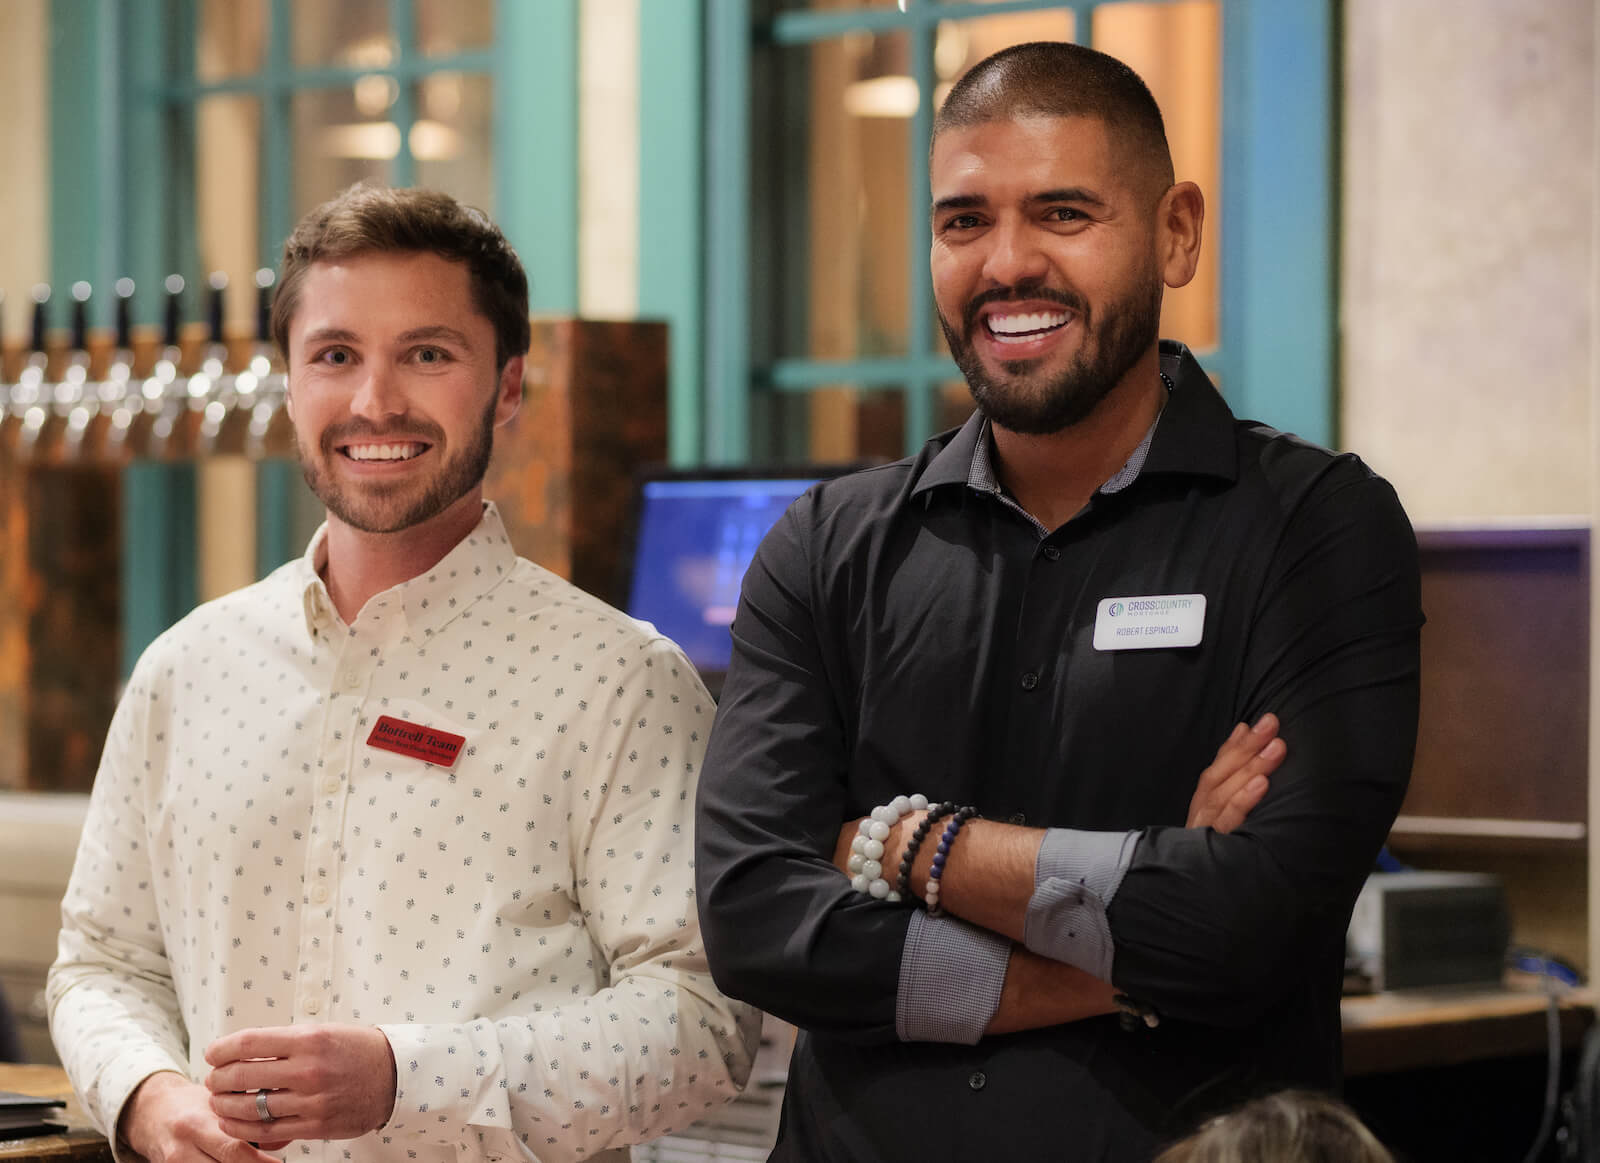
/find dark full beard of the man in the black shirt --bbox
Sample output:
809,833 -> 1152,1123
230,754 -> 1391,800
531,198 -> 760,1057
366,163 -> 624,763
939,270 -> 1162,437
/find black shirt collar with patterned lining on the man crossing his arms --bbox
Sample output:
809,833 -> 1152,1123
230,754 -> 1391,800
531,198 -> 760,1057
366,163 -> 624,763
912,339 -> 1238,496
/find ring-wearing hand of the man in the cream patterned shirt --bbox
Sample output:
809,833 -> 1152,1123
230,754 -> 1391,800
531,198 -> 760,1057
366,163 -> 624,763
205,1025 -> 395,1142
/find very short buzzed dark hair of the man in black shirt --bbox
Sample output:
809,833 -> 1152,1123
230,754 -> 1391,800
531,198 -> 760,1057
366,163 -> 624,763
933,40 -> 1173,186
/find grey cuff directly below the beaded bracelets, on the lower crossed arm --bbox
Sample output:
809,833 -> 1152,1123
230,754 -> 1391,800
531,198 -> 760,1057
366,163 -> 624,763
894,909 -> 1011,1046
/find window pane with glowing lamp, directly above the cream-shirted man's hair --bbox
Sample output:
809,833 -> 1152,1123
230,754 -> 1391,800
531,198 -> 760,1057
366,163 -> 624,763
291,85 -> 388,219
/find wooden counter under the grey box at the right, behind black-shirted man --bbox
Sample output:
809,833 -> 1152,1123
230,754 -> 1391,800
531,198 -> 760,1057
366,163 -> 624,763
1341,985 -> 1595,1077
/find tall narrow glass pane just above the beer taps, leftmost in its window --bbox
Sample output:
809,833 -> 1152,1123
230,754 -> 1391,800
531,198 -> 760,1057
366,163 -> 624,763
190,96 -> 261,330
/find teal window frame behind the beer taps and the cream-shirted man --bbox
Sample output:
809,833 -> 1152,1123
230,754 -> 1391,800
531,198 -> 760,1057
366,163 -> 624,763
50,0 -> 579,673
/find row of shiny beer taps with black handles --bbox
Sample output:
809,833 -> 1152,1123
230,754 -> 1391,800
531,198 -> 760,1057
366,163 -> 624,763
0,269 -> 294,462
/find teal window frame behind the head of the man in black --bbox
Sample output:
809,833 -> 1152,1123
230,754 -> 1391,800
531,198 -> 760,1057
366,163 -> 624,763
638,0 -> 1339,464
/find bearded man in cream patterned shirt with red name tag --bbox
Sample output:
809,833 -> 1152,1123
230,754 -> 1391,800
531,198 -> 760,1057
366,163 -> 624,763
50,186 -> 758,1163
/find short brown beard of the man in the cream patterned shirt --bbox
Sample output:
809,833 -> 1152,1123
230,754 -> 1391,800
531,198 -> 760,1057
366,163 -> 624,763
294,394 -> 498,533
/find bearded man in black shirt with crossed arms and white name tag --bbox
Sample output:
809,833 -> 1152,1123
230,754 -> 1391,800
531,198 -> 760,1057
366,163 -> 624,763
698,43 -> 1422,1163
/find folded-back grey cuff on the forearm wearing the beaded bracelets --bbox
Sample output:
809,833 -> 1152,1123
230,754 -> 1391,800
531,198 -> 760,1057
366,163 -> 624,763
1022,827 -> 1139,981
